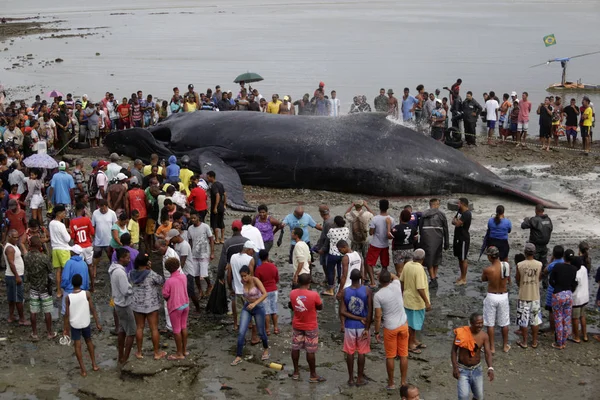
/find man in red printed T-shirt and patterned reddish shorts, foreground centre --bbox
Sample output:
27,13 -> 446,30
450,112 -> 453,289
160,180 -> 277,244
290,274 -> 326,383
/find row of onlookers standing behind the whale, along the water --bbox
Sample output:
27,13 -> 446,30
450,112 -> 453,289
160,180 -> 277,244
0,79 -> 595,156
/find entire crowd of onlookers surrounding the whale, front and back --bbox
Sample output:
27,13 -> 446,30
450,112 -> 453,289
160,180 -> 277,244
0,82 -> 600,399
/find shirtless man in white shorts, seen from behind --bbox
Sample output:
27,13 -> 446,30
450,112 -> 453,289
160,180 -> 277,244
481,246 -> 510,354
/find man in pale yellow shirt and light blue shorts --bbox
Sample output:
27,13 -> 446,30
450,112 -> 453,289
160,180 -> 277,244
399,249 -> 431,354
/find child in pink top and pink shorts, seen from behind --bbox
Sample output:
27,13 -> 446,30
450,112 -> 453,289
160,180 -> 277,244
163,257 -> 190,360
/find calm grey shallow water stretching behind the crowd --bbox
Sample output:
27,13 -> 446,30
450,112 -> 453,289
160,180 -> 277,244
0,0 -> 600,112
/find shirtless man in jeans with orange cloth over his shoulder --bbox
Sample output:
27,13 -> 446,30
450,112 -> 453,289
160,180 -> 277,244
451,313 -> 494,400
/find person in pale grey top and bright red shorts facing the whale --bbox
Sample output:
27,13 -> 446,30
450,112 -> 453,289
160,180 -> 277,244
367,199 -> 394,285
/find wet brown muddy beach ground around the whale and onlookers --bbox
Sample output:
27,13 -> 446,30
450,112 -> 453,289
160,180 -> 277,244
0,138 -> 600,399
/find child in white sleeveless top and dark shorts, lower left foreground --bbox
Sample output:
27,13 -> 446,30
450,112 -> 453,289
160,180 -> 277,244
63,274 -> 102,377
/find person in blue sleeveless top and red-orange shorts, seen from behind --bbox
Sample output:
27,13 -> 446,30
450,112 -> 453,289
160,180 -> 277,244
340,268 -> 373,386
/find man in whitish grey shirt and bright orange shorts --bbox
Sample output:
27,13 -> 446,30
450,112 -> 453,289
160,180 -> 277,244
373,269 -> 409,390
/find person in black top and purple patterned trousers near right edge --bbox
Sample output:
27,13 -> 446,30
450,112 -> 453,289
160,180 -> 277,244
549,250 -> 577,350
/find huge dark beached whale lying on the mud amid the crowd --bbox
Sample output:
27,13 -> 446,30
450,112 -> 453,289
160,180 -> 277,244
104,112 -> 562,210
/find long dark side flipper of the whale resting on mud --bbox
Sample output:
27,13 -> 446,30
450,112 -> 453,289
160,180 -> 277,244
198,150 -> 256,211
